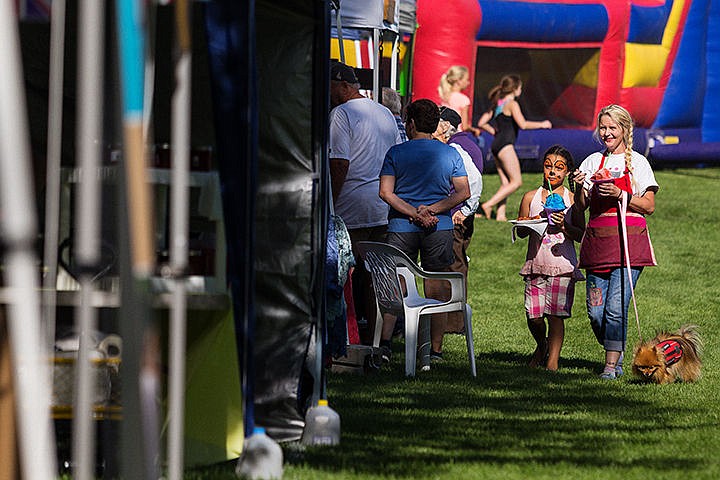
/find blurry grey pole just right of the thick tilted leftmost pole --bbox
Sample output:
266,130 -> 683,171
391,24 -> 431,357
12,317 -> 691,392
43,0 -> 65,352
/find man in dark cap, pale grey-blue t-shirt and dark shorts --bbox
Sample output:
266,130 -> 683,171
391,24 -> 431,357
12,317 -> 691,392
329,62 -> 400,344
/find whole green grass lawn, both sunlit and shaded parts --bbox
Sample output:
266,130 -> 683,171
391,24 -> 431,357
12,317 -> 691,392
191,169 -> 720,480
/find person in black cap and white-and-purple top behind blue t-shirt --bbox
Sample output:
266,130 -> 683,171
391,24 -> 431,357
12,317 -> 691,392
435,107 -> 483,333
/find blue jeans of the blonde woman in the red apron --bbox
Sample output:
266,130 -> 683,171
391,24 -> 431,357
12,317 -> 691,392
586,267 -> 642,352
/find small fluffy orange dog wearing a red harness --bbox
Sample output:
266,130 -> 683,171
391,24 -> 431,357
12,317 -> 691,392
632,325 -> 703,383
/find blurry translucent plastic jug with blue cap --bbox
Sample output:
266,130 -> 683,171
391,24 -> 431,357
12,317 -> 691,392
235,427 -> 283,480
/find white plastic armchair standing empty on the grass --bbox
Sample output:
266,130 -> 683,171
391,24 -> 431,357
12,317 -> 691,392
358,242 -> 477,377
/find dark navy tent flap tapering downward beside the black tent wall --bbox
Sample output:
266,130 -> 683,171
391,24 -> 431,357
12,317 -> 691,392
205,1 -> 257,436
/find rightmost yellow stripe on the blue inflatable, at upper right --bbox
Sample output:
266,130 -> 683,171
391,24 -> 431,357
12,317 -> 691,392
622,0 -> 687,88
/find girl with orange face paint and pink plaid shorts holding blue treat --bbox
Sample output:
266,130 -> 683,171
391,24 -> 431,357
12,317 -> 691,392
518,145 -> 584,371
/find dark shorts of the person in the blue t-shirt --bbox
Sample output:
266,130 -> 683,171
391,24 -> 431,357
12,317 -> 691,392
387,230 -> 455,272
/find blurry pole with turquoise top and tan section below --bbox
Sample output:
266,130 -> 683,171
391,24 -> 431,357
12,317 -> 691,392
116,0 -> 161,479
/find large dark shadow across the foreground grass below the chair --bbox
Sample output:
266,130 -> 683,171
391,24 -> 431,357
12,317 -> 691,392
286,351 -> 701,478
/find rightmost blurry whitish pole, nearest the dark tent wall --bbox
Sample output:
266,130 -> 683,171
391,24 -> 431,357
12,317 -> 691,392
168,0 -> 192,480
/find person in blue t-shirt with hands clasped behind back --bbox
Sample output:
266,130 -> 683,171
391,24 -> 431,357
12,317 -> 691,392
380,99 -> 470,360
